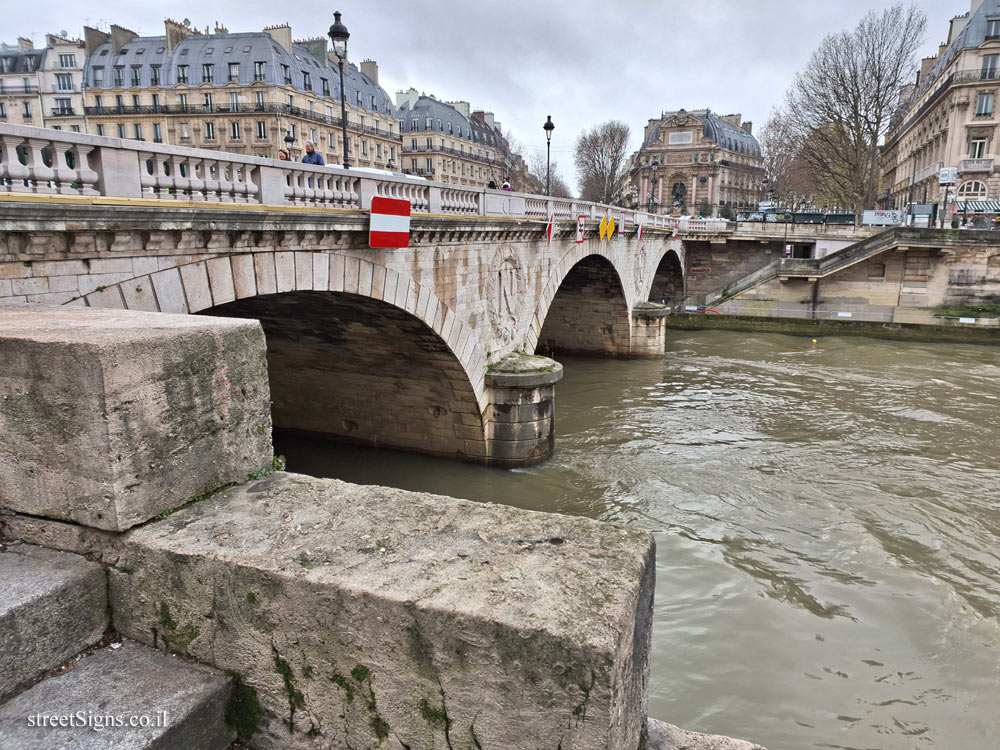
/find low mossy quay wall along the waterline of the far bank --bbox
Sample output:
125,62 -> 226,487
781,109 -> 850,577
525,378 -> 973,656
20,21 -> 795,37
667,313 -> 1000,345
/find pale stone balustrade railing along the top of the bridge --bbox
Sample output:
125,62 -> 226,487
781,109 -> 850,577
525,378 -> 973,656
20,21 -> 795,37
0,124 -> 735,233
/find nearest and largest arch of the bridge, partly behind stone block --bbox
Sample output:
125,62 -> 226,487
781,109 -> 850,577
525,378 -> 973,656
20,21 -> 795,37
70,251 -> 488,461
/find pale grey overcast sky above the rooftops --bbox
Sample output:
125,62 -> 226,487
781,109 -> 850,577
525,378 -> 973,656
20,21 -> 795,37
7,0 -> 969,185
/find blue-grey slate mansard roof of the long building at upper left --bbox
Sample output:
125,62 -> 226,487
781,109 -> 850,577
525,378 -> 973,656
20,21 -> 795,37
84,32 -> 395,117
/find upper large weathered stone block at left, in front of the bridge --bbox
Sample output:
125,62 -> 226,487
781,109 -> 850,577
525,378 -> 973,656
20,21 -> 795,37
0,308 -> 271,530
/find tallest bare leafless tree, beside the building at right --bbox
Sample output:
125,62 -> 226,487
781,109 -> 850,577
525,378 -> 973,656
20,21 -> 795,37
784,3 -> 927,214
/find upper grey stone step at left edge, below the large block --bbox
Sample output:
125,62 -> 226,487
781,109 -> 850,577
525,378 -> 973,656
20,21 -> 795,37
0,544 -> 108,698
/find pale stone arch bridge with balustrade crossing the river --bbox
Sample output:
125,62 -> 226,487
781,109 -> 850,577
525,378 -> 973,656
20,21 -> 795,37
0,126 -> 725,466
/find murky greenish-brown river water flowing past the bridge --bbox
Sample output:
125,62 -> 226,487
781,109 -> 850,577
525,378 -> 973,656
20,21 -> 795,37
277,331 -> 1000,750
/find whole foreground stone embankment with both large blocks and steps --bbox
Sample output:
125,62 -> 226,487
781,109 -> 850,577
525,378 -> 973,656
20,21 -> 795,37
0,309 -> 756,750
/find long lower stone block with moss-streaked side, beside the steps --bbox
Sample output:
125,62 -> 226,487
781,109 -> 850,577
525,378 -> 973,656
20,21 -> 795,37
110,474 -> 654,750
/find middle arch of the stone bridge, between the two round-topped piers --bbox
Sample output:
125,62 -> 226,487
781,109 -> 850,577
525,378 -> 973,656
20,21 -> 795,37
526,246 -> 631,356
